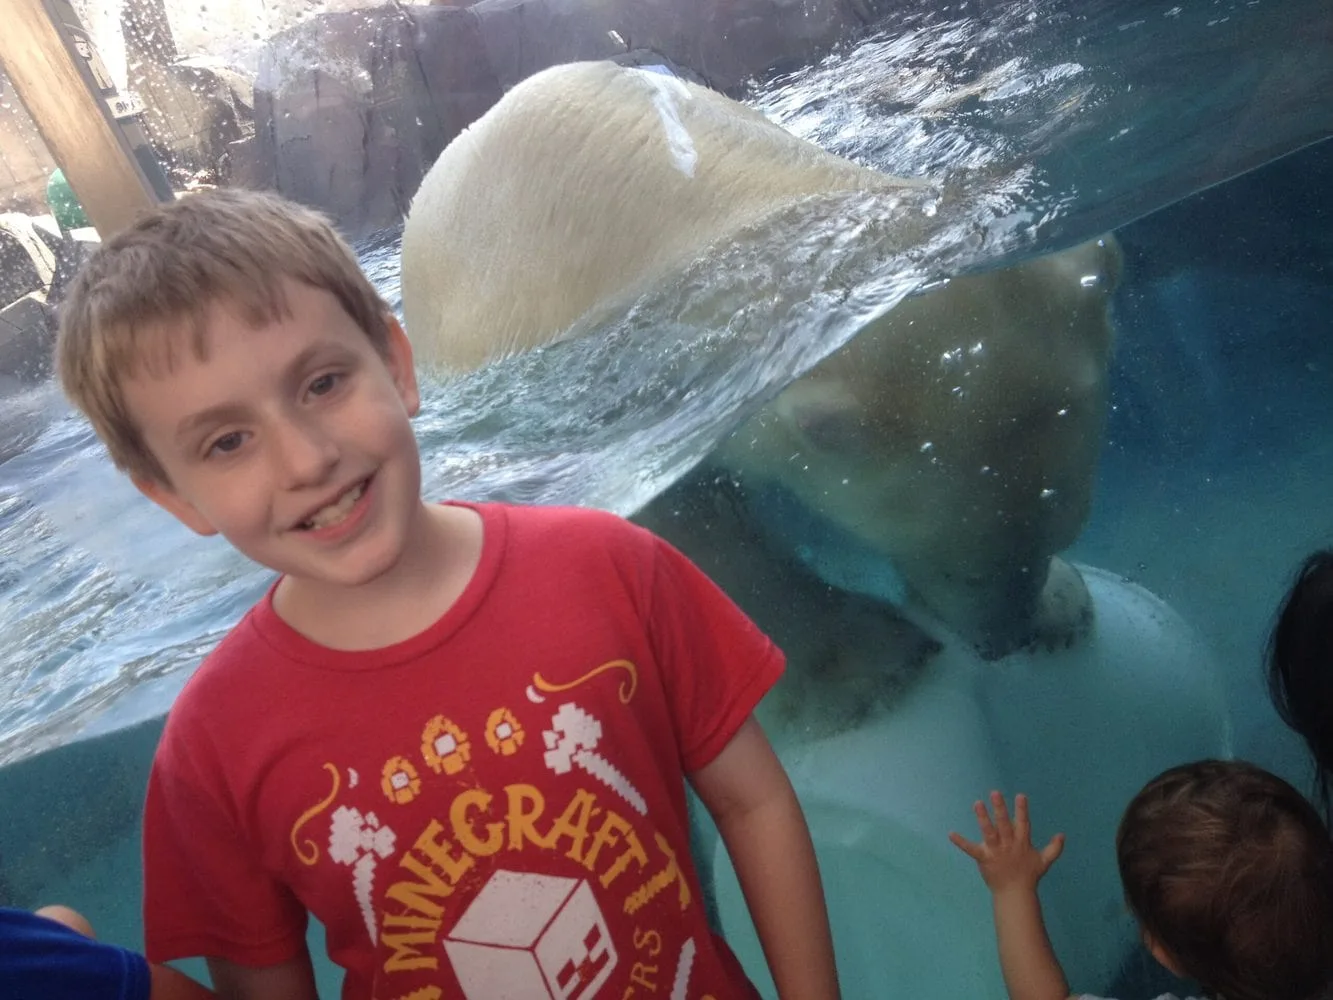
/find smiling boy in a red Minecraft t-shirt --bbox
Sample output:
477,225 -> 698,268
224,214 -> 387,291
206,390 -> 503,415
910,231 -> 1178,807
57,192 -> 837,1000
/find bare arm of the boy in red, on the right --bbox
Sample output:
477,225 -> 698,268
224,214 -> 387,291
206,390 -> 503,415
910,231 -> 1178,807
690,716 -> 838,1000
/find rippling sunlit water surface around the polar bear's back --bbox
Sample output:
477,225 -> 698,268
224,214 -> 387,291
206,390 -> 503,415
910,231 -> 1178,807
0,3 -> 1333,763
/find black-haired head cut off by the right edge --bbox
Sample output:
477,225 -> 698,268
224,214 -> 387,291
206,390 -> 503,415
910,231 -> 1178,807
1268,549 -> 1333,817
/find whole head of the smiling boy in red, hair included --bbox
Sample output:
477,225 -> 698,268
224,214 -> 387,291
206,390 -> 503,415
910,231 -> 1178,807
57,192 -> 424,587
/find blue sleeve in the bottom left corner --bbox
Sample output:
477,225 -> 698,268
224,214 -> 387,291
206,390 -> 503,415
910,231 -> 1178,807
0,908 -> 152,1000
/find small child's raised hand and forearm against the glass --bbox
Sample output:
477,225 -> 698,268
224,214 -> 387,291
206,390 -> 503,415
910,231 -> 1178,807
949,792 -> 1069,1000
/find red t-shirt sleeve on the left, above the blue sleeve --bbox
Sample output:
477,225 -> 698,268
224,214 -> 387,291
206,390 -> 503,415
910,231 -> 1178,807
144,720 -> 305,967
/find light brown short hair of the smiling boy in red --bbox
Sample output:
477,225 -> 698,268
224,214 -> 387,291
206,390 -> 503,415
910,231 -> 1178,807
56,191 -> 391,484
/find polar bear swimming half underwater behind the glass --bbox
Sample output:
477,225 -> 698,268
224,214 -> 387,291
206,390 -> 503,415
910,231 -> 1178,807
403,63 -> 1118,656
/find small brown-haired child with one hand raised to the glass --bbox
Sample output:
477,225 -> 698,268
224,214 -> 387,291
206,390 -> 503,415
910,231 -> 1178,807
949,760 -> 1333,1000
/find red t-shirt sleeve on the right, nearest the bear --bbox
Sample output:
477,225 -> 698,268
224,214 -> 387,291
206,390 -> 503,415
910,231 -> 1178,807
651,537 -> 785,773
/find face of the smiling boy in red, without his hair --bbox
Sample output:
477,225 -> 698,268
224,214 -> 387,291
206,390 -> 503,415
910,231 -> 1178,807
124,281 -> 421,587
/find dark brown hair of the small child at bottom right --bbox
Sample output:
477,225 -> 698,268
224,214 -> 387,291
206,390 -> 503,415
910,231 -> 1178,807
1116,760 -> 1333,1000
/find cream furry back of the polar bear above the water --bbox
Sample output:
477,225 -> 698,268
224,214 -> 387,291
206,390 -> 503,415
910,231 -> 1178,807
403,63 -> 922,371
